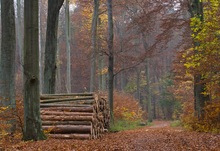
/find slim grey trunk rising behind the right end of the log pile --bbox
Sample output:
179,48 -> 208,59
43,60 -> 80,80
90,0 -> 99,92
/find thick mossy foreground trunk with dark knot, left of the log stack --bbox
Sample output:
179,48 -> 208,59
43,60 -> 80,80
23,0 -> 45,141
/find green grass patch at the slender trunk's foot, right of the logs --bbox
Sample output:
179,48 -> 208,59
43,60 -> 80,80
110,120 -> 141,132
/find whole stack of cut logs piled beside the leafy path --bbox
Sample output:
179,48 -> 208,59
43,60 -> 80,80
40,93 -> 110,139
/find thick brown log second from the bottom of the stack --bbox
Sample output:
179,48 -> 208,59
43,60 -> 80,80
42,125 -> 92,134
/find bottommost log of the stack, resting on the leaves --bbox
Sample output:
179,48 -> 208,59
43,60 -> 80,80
48,134 -> 91,140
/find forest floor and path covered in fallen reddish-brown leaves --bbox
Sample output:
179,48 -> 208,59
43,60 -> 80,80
3,121 -> 220,151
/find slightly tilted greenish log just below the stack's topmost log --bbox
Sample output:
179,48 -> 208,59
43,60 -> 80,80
40,96 -> 94,103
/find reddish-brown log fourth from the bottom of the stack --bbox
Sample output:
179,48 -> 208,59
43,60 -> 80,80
41,115 -> 94,121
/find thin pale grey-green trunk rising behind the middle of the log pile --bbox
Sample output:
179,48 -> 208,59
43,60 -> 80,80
65,0 -> 71,93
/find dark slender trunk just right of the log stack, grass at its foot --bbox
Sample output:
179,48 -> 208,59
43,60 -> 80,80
107,0 -> 114,122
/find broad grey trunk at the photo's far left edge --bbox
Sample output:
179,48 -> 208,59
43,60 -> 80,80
0,0 -> 16,131
